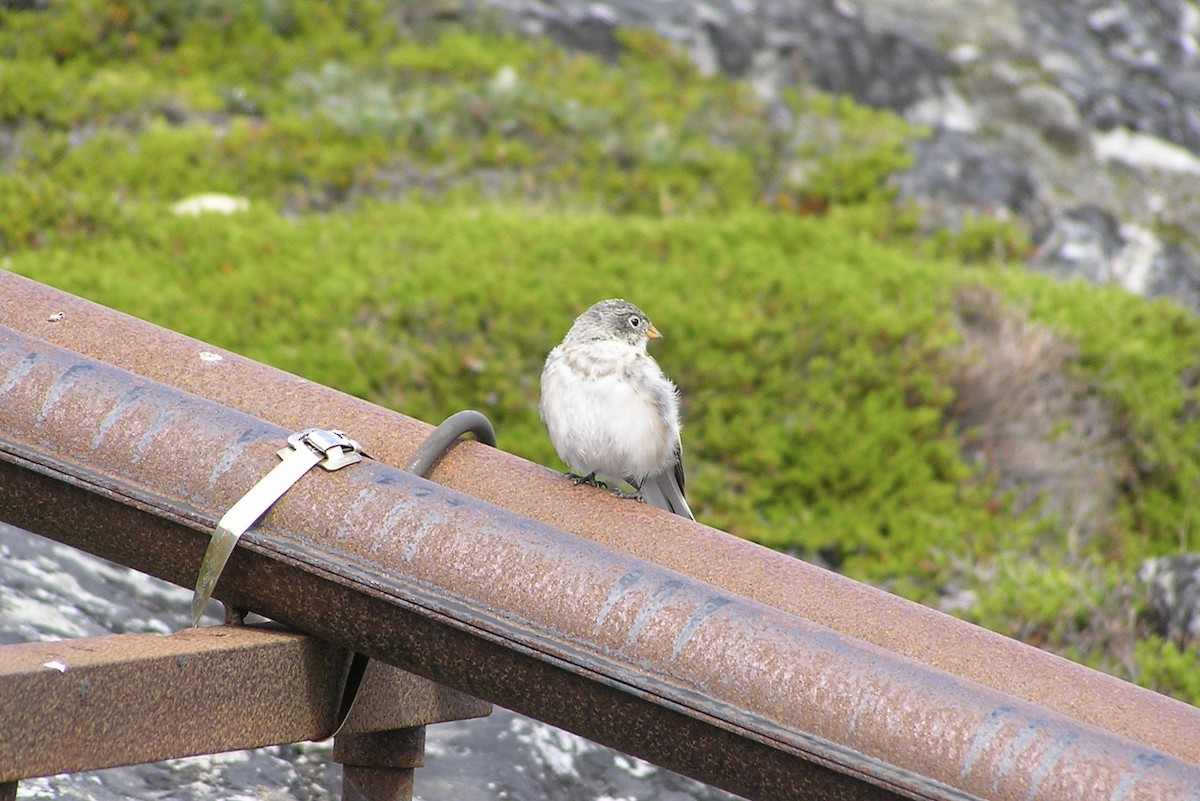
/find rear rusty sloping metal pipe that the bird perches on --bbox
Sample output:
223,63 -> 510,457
0,271 -> 1200,763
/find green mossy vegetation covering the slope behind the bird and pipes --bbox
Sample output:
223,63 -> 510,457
0,0 -> 1200,703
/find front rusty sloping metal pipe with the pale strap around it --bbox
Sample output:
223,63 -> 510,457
0,330 -> 1200,801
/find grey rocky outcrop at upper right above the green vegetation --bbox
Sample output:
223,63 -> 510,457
490,0 -> 1200,308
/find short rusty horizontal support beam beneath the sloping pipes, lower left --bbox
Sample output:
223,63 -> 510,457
0,626 -> 491,783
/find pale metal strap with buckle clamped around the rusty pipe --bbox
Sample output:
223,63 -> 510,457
192,428 -> 362,626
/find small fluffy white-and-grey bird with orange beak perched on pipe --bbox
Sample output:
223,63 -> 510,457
538,299 -> 696,519
